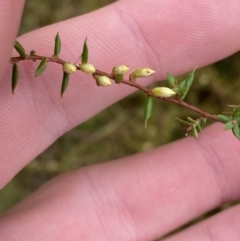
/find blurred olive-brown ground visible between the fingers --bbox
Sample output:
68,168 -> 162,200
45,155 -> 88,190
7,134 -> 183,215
0,0 -> 240,237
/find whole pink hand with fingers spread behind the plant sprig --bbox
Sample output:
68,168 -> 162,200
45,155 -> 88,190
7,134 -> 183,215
0,0 -> 240,241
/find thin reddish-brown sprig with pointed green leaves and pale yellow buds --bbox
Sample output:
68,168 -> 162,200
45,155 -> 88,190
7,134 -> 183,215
10,33 -> 240,140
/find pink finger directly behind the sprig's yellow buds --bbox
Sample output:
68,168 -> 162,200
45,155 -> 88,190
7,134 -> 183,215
0,0 -> 240,187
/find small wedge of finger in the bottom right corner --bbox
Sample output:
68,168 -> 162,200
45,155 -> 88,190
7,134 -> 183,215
162,205 -> 240,241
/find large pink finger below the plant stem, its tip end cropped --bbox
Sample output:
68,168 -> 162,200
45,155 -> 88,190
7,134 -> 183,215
0,124 -> 240,241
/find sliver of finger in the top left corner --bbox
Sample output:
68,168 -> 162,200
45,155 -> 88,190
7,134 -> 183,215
0,0 -> 25,81
